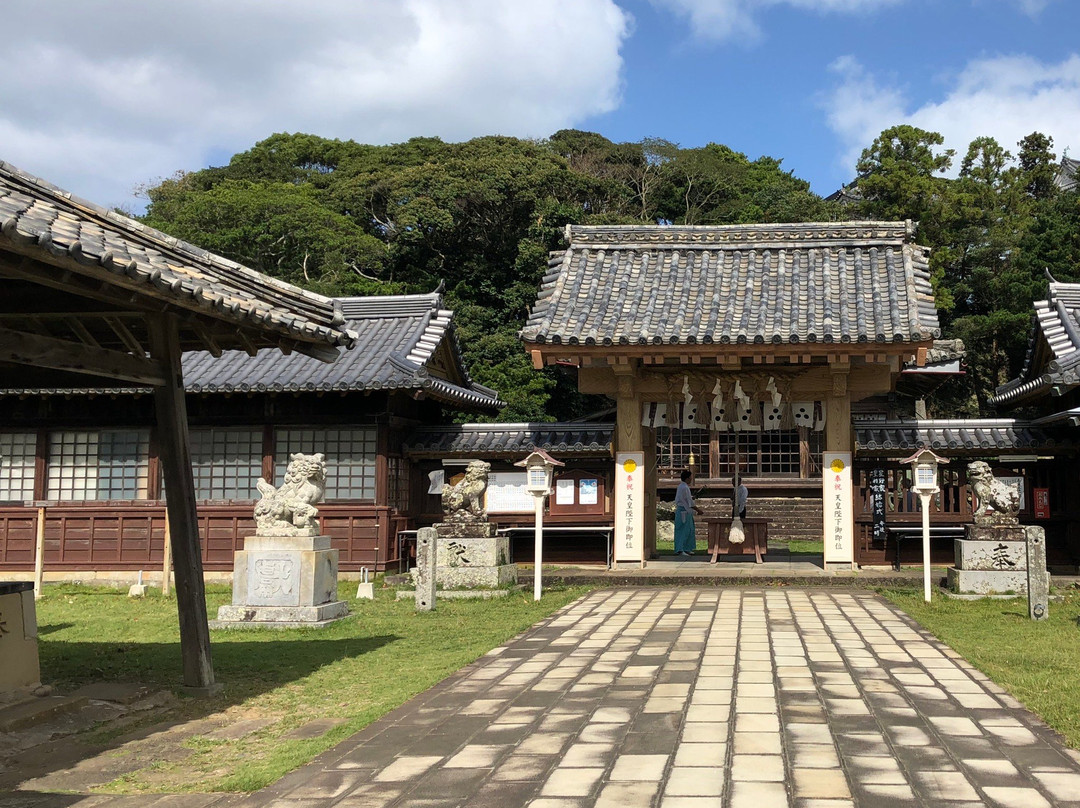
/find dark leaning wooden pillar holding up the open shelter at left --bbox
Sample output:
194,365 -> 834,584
147,314 -> 215,692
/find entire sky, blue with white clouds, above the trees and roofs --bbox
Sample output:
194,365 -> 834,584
0,0 -> 1080,211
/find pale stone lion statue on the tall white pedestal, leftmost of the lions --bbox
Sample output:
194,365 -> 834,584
255,454 -> 326,536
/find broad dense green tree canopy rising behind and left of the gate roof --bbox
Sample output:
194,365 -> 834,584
146,130 -> 836,420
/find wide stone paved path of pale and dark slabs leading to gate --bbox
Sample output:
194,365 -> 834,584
238,589 -> 1080,808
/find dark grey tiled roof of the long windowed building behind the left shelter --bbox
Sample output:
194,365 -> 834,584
0,294 -> 502,412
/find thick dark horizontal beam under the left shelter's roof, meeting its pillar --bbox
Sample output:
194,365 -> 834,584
0,328 -> 165,386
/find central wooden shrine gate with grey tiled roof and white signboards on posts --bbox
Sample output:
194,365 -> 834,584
522,221 -> 941,564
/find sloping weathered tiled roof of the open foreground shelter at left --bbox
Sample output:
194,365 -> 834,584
0,161 -> 353,358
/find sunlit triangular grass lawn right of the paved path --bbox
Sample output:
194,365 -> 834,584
881,590 -> 1080,749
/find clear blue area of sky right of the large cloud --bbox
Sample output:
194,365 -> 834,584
596,0 -> 1080,194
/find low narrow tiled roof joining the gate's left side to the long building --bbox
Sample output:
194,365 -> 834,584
404,423 -> 615,458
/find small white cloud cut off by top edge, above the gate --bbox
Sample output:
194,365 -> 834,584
651,0 -> 902,40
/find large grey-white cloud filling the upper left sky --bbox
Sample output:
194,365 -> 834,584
0,0 -> 632,211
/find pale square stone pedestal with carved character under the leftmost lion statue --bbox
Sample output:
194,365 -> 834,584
211,536 -> 349,629
